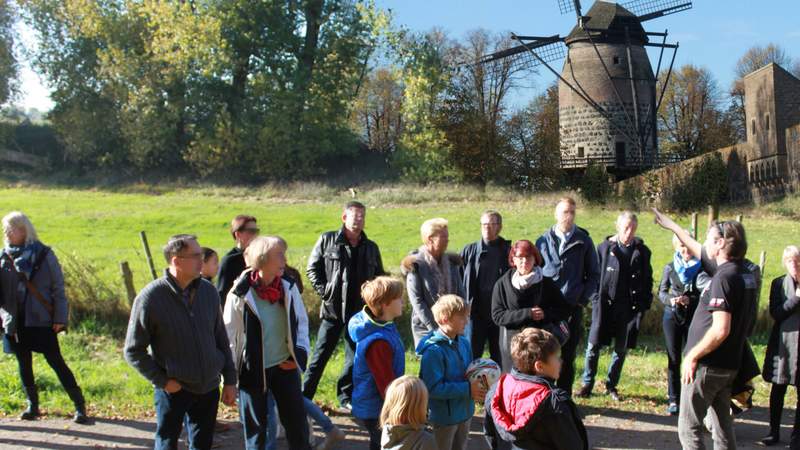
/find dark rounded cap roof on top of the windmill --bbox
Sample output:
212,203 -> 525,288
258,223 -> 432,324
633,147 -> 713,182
565,0 -> 648,45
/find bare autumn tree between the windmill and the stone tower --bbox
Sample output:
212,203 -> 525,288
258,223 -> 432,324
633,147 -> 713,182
658,64 -> 735,159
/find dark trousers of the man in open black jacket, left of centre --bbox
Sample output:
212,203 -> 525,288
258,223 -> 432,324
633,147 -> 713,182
303,319 -> 356,405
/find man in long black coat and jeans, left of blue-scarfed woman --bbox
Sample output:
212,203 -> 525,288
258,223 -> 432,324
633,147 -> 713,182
577,211 -> 653,401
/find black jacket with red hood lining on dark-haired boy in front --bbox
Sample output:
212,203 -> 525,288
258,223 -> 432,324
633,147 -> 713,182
485,369 -> 589,450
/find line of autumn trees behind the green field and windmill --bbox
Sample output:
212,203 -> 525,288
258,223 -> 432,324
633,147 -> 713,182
0,0 -> 800,190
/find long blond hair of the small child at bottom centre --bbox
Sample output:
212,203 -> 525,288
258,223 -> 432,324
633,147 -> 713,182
380,375 -> 428,428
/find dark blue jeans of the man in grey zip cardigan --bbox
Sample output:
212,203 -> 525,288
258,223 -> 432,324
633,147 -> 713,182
154,389 -> 219,450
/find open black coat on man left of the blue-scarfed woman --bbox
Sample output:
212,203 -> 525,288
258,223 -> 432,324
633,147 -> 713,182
589,237 -> 653,348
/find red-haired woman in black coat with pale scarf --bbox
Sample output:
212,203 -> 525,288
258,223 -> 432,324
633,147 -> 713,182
492,240 -> 570,373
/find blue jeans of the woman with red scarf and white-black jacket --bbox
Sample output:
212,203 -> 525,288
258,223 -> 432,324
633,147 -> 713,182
239,366 -> 311,450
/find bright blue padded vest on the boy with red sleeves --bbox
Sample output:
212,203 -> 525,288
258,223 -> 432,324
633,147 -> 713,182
347,310 -> 406,419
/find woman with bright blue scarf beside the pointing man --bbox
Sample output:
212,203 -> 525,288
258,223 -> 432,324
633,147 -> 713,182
658,236 -> 711,416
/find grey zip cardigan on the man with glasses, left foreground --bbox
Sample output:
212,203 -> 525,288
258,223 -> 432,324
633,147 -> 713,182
124,272 -> 236,394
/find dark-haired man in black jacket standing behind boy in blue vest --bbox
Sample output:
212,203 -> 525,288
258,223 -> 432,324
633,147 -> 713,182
303,201 -> 385,409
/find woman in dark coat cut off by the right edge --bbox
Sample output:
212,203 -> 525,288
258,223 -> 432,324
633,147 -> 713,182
761,245 -> 800,449
